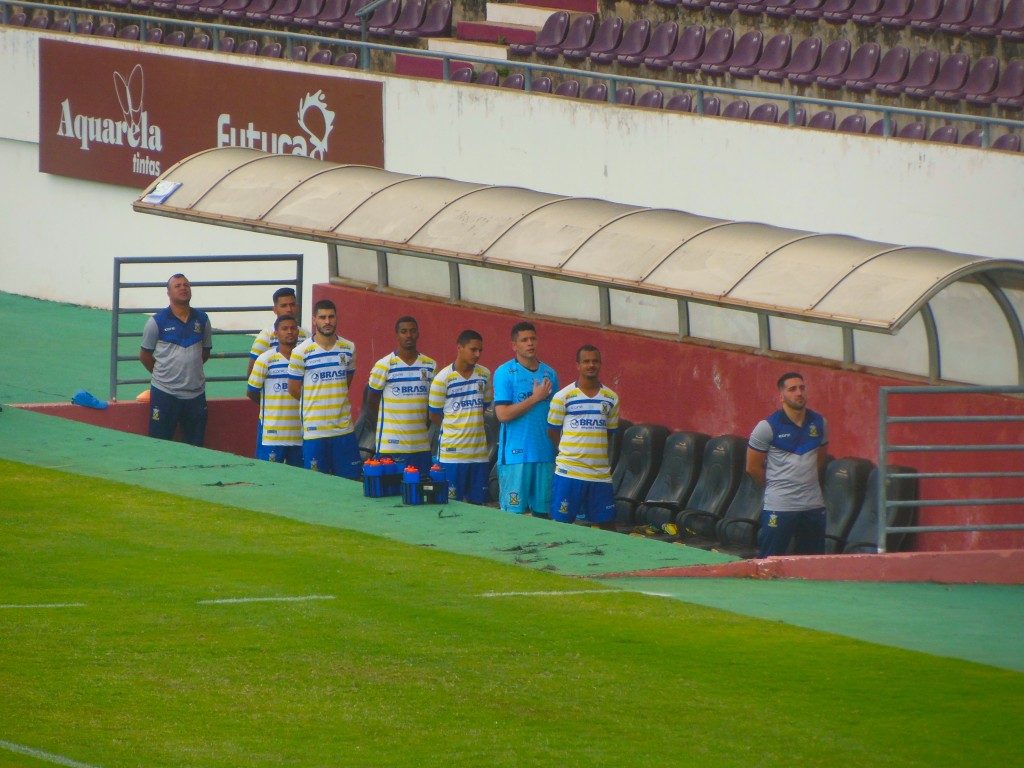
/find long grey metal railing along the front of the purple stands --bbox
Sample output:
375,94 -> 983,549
8,0 -> 1024,146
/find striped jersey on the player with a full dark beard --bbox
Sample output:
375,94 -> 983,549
288,336 -> 355,440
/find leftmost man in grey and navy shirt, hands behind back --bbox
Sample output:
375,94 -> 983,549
138,273 -> 213,445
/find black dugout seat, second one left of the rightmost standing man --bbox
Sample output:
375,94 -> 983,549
676,434 -> 746,539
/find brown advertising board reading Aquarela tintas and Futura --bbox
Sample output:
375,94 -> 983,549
39,39 -> 384,188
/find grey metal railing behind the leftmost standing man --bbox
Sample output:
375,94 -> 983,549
110,254 -> 303,400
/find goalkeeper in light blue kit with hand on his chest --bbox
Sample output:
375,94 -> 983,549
495,322 -> 558,517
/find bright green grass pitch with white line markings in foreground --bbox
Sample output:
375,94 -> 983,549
0,463 -> 1024,768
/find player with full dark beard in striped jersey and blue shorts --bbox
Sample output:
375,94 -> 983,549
288,299 -> 362,480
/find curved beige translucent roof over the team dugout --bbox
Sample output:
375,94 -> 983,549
133,147 -> 1024,333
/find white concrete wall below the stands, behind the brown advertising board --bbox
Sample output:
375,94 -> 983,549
0,28 -> 1024,327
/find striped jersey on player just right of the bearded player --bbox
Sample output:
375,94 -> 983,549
369,353 -> 437,454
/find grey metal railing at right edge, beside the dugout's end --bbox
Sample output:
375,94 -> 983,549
878,386 -> 1024,552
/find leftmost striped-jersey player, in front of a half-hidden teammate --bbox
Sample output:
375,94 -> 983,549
246,314 -> 302,467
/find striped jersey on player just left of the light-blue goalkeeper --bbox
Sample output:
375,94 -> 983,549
429,366 -> 494,464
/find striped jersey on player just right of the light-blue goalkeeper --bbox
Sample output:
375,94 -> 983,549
548,382 -> 618,481
